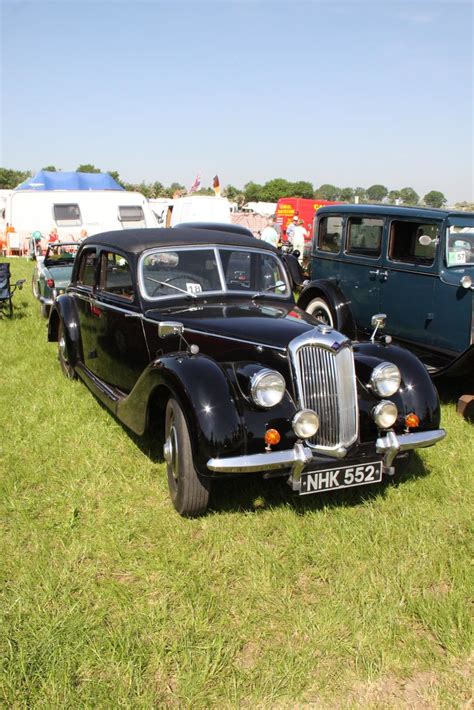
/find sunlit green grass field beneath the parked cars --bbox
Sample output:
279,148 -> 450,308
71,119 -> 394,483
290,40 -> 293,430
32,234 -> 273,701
0,259 -> 474,708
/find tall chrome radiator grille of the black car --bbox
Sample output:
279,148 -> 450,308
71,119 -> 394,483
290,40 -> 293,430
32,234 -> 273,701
290,329 -> 359,452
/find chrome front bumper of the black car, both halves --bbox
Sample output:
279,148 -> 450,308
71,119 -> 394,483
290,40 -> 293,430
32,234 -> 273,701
207,429 -> 446,481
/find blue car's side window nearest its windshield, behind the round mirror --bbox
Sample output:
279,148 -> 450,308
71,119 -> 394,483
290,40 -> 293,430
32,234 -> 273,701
389,220 -> 439,266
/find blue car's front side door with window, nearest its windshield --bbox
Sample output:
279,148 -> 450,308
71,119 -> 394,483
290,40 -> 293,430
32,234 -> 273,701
377,217 -> 441,347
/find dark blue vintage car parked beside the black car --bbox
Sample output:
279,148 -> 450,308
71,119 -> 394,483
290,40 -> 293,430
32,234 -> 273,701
298,205 -> 474,376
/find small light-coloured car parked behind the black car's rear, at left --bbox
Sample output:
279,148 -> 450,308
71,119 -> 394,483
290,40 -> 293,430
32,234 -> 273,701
32,242 -> 79,318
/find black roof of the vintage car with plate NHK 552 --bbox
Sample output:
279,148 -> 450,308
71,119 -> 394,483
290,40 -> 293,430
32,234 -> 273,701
81,227 -> 277,254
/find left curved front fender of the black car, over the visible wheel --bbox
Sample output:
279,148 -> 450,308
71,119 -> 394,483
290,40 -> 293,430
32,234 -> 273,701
116,353 -> 245,473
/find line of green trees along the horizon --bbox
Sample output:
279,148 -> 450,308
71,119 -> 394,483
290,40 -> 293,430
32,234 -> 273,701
0,163 -> 468,209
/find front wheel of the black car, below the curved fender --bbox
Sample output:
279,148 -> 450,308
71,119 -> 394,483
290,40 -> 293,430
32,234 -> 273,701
163,399 -> 211,518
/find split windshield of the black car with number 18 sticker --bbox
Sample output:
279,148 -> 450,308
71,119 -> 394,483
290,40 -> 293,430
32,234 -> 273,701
139,247 -> 290,299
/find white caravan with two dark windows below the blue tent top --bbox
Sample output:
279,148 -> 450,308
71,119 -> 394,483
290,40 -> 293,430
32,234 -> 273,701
5,190 -> 158,251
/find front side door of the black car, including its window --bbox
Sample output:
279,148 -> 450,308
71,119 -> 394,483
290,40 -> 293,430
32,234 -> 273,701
91,250 -> 150,392
